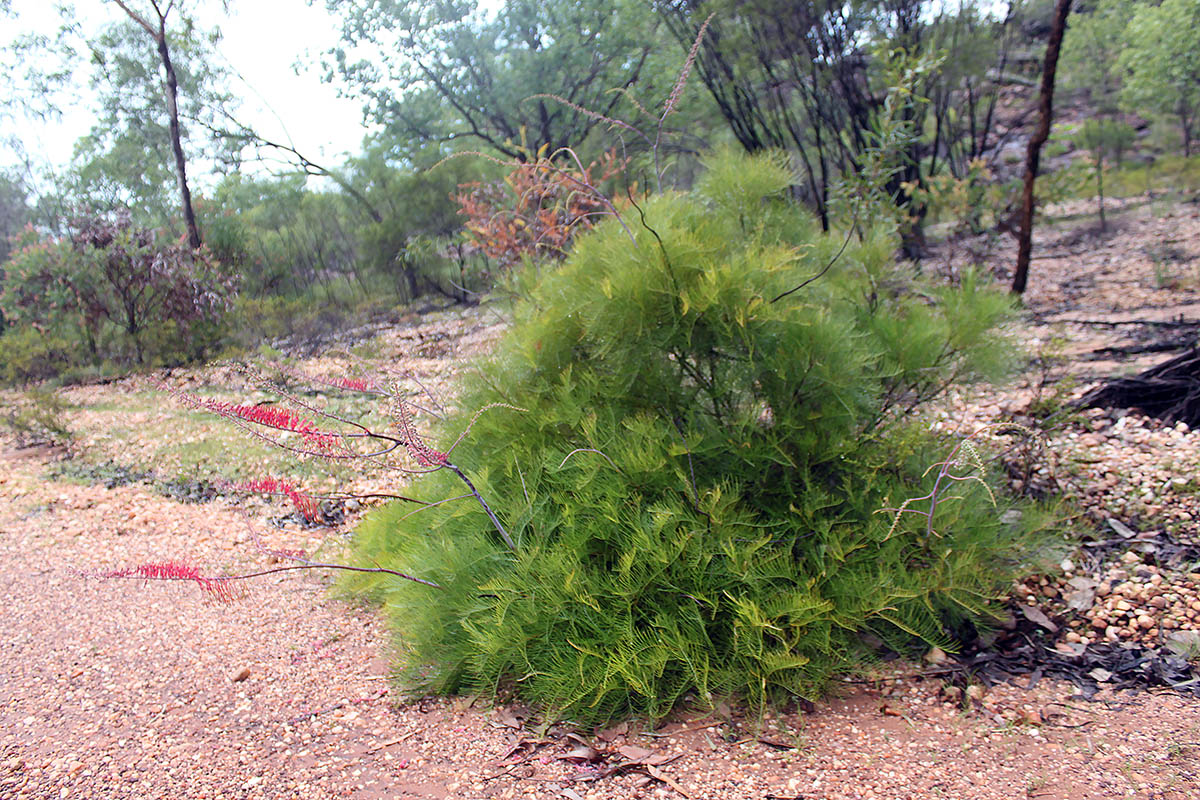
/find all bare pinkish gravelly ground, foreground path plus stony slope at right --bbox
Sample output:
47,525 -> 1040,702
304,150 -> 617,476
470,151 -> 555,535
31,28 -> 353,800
0,195 -> 1200,800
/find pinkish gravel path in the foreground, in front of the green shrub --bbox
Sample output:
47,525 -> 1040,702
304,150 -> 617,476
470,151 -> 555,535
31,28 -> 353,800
0,443 -> 1200,800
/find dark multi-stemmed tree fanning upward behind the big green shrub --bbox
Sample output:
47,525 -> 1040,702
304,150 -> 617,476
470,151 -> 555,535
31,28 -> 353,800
653,0 -> 929,251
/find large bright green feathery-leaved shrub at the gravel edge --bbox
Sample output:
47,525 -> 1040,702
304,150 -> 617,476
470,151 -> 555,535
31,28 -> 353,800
348,149 -> 1036,722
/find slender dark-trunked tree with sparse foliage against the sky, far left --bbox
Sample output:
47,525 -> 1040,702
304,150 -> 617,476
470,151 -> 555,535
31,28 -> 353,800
0,0 -> 232,248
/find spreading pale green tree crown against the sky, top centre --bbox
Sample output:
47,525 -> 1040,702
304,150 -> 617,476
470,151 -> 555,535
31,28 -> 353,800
326,0 -> 655,161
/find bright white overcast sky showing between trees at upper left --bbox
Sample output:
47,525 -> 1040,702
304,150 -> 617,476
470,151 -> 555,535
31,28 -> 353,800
0,0 -> 367,181
